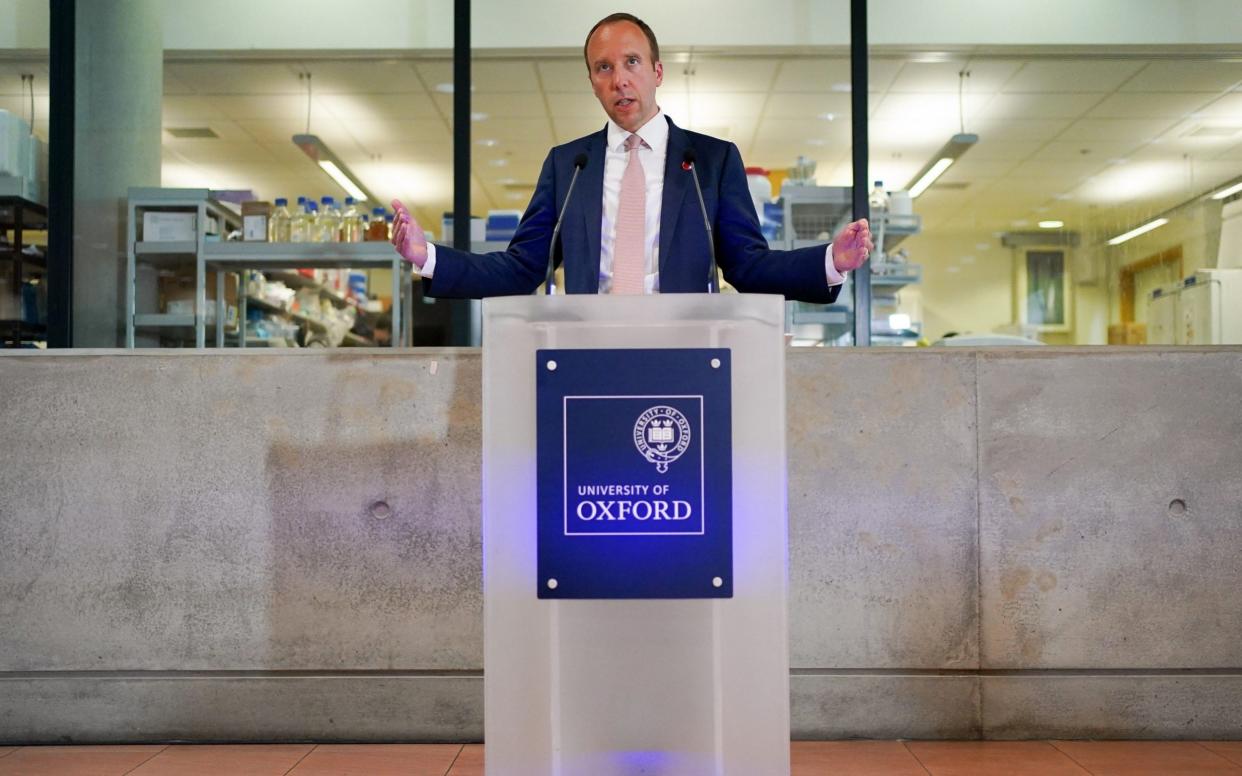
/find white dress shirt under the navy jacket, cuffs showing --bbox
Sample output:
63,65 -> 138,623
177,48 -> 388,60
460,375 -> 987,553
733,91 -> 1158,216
419,111 -> 846,294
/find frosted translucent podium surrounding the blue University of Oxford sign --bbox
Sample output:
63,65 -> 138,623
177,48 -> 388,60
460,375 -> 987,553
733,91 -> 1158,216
483,294 -> 790,776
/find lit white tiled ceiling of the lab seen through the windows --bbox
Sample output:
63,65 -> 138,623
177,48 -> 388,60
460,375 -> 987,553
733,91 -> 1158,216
0,50 -> 1242,239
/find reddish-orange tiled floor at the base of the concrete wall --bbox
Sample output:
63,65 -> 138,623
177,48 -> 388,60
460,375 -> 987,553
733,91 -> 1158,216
0,741 -> 1242,776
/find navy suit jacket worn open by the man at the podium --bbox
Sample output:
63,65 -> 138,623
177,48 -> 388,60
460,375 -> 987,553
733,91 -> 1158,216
425,119 -> 841,304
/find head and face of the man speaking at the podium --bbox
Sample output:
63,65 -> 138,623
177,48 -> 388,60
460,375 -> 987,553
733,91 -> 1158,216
586,21 -> 664,132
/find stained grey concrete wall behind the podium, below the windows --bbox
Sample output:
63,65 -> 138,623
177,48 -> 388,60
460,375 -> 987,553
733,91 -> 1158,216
0,348 -> 1242,742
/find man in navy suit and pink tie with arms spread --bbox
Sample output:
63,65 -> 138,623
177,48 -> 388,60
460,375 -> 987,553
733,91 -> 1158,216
392,14 -> 872,303
